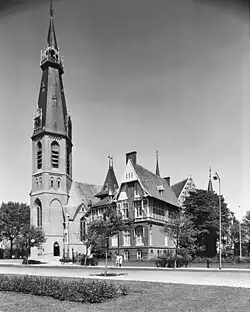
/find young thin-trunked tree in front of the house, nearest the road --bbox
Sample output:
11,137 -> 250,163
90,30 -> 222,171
88,207 -> 133,276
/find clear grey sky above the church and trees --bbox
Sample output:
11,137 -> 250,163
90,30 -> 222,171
0,0 -> 250,218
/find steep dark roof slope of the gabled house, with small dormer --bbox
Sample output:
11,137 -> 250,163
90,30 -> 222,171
132,163 -> 179,206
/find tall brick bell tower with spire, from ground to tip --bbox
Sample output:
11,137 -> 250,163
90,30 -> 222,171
30,0 -> 73,256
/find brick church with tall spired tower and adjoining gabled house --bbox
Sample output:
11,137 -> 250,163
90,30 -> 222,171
30,5 -> 195,260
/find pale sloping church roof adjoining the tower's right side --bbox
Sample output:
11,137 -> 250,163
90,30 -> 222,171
65,182 -> 101,219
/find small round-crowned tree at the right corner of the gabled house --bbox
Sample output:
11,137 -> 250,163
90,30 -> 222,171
164,212 -> 197,268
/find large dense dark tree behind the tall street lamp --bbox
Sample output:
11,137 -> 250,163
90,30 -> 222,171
183,189 -> 231,257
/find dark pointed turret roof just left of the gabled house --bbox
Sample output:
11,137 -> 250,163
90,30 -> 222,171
95,155 -> 118,199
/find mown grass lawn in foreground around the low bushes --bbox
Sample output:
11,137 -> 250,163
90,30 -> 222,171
0,281 -> 250,312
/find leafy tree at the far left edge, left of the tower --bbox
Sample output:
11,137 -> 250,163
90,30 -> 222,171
0,202 -> 30,257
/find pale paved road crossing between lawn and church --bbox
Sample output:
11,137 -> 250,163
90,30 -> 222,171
0,266 -> 250,288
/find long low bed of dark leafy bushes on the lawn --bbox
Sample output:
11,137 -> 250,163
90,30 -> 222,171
0,275 -> 128,303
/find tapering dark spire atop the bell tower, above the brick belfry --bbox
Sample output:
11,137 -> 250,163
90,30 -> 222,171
33,0 -> 72,141
